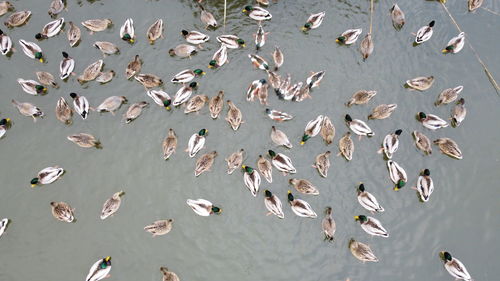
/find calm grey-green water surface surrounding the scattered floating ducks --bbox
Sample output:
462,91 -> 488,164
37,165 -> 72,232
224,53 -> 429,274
0,0 -> 500,281
